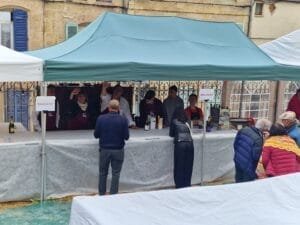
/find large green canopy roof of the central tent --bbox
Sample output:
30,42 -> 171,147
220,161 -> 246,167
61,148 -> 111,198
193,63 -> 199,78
29,13 -> 298,81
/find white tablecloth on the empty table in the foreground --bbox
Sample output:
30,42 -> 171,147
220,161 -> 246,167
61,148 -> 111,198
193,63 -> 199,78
70,173 -> 300,225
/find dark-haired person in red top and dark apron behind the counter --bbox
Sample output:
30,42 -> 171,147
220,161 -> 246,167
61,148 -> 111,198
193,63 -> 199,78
185,94 -> 203,125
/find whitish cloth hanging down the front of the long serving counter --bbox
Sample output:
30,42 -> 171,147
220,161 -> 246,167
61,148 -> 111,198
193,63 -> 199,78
0,130 -> 235,201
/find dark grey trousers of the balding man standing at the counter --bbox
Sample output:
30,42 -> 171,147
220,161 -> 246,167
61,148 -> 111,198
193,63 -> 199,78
99,149 -> 124,195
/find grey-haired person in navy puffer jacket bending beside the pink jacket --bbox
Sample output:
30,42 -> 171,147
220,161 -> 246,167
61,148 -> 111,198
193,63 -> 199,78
234,119 -> 271,182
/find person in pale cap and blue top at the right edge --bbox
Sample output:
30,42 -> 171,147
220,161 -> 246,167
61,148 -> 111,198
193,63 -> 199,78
279,111 -> 300,147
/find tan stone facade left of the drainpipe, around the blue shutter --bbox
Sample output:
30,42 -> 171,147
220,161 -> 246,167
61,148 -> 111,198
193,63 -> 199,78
0,0 -> 123,50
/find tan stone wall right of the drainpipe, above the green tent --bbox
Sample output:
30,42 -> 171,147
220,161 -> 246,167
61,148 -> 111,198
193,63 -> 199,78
128,0 -> 250,33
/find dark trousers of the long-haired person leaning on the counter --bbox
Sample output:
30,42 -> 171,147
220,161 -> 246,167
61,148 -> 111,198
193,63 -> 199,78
174,142 -> 194,188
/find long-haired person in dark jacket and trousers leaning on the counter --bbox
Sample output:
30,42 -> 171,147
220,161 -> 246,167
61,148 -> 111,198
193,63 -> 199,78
169,107 -> 194,188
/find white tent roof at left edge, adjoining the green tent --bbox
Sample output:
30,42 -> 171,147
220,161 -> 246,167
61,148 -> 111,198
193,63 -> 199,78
0,45 -> 43,82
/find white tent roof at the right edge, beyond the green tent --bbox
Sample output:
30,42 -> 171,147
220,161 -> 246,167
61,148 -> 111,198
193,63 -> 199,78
259,30 -> 300,66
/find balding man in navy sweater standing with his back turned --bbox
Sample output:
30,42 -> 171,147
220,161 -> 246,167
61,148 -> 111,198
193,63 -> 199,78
94,100 -> 129,195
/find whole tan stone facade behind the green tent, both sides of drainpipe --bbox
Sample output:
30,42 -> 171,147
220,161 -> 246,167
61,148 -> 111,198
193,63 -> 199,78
0,0 -> 250,50
